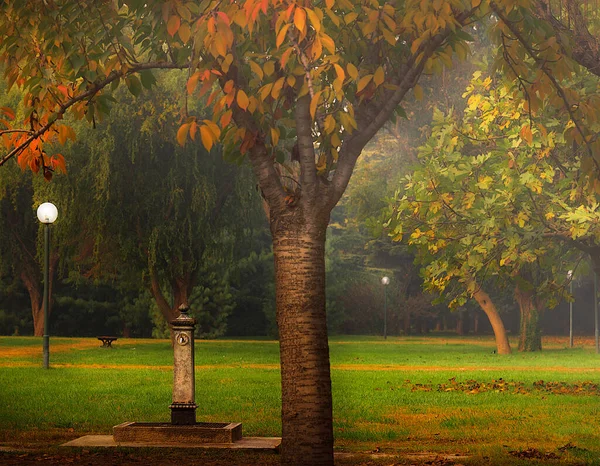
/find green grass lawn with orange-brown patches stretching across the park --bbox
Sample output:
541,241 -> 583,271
0,336 -> 600,465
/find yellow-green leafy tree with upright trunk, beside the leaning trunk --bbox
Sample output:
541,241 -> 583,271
393,73 -> 590,350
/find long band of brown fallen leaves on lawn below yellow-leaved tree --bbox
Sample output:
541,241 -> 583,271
406,377 -> 600,396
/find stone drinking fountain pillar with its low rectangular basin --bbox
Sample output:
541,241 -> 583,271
113,305 -> 242,445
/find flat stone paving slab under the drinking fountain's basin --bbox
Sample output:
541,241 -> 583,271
61,435 -> 281,451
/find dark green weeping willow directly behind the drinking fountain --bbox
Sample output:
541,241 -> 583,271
58,74 -> 262,326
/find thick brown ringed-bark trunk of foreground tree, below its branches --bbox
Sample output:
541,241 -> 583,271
271,207 -> 333,465
